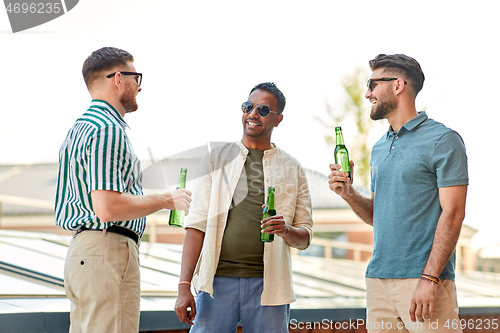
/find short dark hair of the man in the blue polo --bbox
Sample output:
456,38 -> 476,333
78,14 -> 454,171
368,54 -> 425,96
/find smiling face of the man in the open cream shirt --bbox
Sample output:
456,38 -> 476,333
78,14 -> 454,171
242,89 -> 283,150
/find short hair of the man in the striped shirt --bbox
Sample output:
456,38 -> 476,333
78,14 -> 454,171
82,47 -> 134,88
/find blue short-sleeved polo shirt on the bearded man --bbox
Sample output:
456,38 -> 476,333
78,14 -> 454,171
366,111 -> 468,280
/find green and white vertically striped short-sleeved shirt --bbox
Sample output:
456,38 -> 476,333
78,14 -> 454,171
55,100 -> 146,237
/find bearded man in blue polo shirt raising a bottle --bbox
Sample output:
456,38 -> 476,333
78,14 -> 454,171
329,54 -> 468,333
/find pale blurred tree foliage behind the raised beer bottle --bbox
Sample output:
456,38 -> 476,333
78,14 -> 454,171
317,68 -> 373,188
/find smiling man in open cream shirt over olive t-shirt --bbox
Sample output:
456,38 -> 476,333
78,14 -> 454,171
175,82 -> 312,333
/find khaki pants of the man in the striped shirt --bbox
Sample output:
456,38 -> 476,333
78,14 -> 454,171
64,231 -> 141,333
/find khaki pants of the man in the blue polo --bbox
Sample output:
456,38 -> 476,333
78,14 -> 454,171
366,278 -> 462,333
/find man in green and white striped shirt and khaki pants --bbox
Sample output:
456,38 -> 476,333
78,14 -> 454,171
55,47 -> 191,333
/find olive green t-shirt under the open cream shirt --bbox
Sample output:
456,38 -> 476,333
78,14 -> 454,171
215,149 -> 264,277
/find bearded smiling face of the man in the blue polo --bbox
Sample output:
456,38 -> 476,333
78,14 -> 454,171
365,68 -> 398,120
